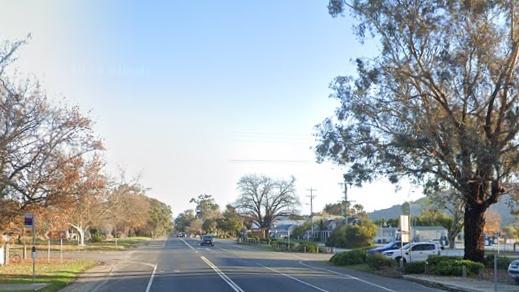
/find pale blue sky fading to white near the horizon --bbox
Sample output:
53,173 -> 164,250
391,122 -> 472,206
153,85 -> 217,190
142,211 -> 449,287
0,0 -> 421,214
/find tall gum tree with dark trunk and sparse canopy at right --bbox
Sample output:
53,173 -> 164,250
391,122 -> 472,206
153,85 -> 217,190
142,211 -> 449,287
316,0 -> 519,261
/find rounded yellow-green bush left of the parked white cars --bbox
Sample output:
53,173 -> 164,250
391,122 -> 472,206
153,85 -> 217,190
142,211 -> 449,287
326,219 -> 377,248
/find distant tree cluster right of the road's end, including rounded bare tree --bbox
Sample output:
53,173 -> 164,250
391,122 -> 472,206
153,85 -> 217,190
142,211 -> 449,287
175,175 -> 299,238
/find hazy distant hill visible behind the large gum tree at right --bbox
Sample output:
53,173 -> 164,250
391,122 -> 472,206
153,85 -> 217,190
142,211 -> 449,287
368,196 -> 517,227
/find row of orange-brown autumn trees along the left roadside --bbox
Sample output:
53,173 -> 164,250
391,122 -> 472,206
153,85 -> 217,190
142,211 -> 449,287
0,40 -> 172,244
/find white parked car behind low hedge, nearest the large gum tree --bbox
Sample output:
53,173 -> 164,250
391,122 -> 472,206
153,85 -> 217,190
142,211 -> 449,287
382,242 -> 441,263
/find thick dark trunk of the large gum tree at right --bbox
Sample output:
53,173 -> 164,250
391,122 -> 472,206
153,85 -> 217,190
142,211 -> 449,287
463,204 -> 485,262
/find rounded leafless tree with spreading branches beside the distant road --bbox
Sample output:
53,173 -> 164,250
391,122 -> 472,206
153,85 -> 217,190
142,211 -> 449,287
236,175 -> 299,237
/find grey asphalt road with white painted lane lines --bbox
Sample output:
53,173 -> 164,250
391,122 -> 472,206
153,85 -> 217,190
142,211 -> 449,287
63,238 -> 437,292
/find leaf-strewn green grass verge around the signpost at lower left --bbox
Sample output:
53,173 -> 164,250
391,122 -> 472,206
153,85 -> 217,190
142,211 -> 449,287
0,260 -> 97,292
